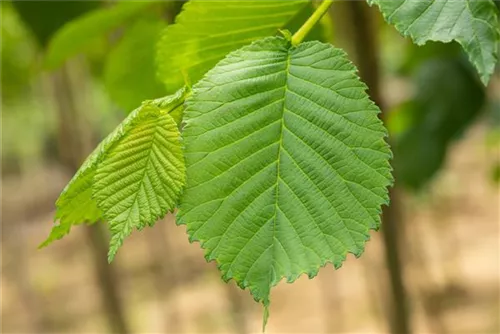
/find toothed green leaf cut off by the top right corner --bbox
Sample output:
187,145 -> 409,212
367,0 -> 500,85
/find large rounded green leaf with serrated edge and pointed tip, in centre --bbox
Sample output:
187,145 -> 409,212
178,37 -> 392,314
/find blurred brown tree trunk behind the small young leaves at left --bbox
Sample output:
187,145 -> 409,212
52,63 -> 129,334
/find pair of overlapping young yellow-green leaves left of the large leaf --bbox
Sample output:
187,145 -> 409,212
41,90 -> 186,258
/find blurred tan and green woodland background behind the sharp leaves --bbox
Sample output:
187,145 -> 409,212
0,0 -> 500,334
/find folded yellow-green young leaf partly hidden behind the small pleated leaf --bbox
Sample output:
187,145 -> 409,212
46,89 -> 187,247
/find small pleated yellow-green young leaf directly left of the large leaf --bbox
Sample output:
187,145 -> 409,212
92,104 -> 185,261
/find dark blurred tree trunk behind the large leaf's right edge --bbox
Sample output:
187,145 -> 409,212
346,0 -> 410,334
